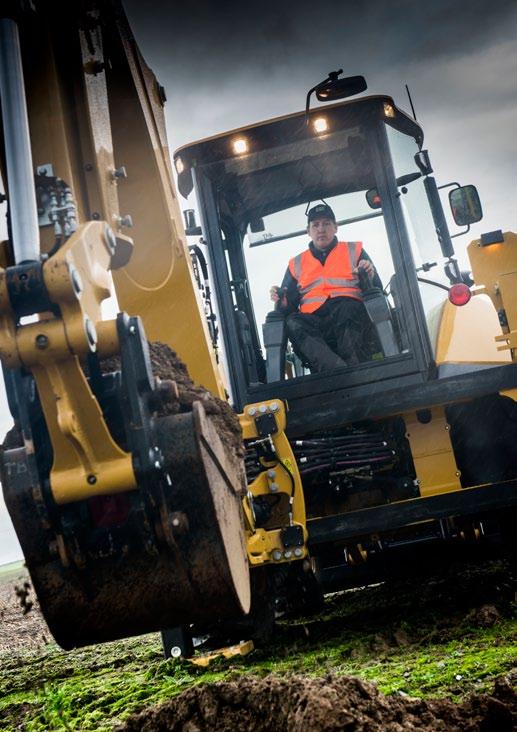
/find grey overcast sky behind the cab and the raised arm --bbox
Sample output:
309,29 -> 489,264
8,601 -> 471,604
0,0 -> 517,563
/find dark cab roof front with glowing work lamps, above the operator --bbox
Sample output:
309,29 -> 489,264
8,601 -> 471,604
174,95 -> 423,217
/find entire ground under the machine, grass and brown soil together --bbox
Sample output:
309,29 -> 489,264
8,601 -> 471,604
0,562 -> 517,732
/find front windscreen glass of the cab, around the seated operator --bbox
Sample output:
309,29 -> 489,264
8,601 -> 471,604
196,106 -> 422,383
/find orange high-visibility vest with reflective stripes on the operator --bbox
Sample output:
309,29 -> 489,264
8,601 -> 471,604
289,241 -> 363,313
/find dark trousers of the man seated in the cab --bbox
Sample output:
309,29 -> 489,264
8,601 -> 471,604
286,297 -> 371,372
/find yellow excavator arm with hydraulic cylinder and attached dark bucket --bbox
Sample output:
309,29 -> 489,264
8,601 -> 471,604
0,0 -> 250,648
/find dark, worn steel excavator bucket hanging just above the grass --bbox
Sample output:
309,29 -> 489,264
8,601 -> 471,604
2,402 -> 249,649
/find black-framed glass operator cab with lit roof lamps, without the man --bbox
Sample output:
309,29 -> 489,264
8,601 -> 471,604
174,96 -> 476,420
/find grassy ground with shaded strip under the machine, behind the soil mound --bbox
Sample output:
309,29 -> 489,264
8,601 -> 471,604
0,562 -> 517,731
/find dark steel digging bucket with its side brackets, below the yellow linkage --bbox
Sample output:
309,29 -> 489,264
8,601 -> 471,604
1,319 -> 250,649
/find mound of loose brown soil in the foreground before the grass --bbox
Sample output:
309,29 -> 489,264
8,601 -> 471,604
117,676 -> 517,732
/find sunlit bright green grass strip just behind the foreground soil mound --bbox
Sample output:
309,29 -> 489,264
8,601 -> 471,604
0,618 -> 517,732
